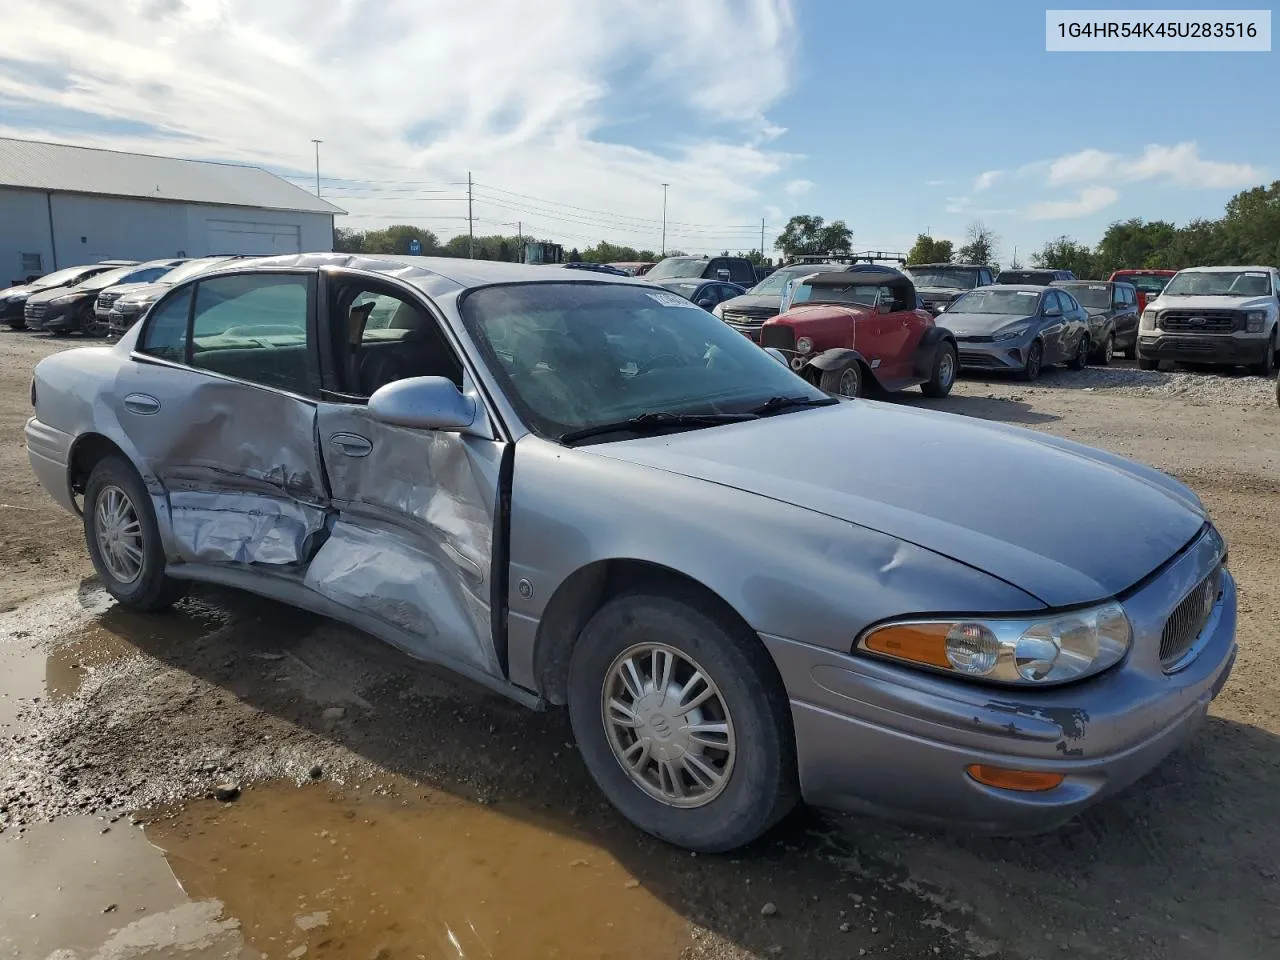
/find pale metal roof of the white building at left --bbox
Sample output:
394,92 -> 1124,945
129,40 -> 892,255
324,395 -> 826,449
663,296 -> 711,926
0,137 -> 346,214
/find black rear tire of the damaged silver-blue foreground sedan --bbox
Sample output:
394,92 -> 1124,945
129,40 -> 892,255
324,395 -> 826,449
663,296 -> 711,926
84,456 -> 187,611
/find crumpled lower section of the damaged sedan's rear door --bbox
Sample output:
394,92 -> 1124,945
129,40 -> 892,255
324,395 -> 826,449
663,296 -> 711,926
169,490 -> 325,566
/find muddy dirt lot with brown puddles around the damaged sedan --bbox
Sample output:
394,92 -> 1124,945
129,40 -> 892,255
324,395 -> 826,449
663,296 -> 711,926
0,333 -> 1280,960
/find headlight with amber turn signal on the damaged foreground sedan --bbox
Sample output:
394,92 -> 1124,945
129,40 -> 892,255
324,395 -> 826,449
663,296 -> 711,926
858,602 -> 1133,685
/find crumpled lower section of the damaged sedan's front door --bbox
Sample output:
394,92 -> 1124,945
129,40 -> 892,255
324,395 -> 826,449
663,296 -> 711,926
305,521 -> 497,673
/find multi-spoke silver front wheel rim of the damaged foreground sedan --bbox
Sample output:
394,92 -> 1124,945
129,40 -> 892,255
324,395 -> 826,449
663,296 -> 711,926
600,644 -> 737,808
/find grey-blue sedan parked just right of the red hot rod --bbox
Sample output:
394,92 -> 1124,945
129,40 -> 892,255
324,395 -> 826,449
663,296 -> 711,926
937,284 -> 1093,380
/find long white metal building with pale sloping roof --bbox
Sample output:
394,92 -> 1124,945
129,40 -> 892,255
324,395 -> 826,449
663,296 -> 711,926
0,138 -> 344,287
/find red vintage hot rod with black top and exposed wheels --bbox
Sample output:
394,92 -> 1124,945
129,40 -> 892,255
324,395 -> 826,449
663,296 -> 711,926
760,264 -> 957,397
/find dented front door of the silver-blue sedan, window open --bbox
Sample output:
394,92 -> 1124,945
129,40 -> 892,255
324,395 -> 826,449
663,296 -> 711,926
306,271 -> 507,675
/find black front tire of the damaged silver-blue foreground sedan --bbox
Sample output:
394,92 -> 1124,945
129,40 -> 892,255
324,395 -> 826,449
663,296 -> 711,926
568,589 -> 799,852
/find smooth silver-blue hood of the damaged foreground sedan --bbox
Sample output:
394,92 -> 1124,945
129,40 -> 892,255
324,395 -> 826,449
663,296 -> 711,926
582,401 -> 1207,607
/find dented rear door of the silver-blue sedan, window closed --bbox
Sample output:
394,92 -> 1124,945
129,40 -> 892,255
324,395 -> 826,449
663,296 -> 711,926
119,270 -> 328,568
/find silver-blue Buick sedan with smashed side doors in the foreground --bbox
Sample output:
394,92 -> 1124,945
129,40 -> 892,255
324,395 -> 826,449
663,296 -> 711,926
27,253 -> 1235,851
